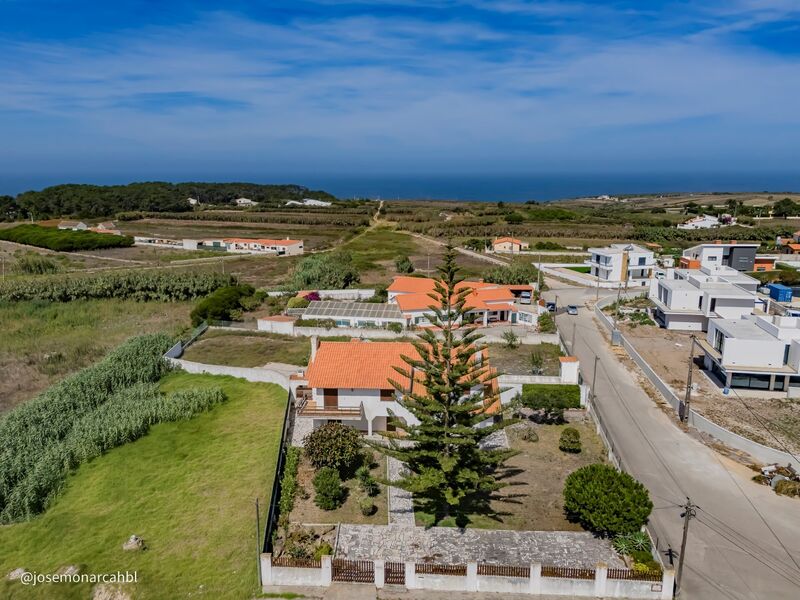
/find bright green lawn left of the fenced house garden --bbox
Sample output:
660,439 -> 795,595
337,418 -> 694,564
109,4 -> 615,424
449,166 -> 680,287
0,373 -> 286,600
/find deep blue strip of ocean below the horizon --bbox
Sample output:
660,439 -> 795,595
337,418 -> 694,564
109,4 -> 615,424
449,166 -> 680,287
0,172 -> 800,202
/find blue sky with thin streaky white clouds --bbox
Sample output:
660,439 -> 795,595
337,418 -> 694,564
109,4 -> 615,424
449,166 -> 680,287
0,0 -> 800,191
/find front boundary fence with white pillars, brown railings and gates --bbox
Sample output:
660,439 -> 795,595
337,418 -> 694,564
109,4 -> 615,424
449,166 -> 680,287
261,553 -> 674,600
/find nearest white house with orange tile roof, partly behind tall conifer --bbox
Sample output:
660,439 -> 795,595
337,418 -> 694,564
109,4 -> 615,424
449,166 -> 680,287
294,338 -> 501,435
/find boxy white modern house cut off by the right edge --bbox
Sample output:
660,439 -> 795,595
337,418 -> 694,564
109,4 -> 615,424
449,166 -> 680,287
700,315 -> 800,391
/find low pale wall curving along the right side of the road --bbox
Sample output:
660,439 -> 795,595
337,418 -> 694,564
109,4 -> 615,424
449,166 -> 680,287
594,297 -> 795,464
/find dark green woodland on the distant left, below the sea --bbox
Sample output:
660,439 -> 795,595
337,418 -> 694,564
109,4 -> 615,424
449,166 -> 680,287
0,181 -> 336,221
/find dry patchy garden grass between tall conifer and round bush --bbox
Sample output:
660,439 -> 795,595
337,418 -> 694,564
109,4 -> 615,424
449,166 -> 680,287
416,423 -> 606,531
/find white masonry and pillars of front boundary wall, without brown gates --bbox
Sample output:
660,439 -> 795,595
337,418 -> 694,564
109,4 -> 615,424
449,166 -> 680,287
261,553 -> 675,600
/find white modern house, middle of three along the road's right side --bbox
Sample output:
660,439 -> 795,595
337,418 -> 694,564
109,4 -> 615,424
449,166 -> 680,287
650,267 -> 762,331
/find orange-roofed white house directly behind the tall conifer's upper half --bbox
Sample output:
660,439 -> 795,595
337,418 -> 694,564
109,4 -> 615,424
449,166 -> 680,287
386,276 -> 540,327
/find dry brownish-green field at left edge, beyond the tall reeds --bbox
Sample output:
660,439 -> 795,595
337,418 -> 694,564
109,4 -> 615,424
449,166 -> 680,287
0,299 -> 192,412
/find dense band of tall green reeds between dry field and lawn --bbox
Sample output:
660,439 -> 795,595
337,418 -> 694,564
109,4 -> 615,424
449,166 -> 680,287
0,334 -> 183,523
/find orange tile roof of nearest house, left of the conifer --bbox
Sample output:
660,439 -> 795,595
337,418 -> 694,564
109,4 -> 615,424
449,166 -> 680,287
306,341 -> 419,390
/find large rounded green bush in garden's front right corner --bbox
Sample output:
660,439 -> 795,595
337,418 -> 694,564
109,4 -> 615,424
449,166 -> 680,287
564,464 -> 653,537
